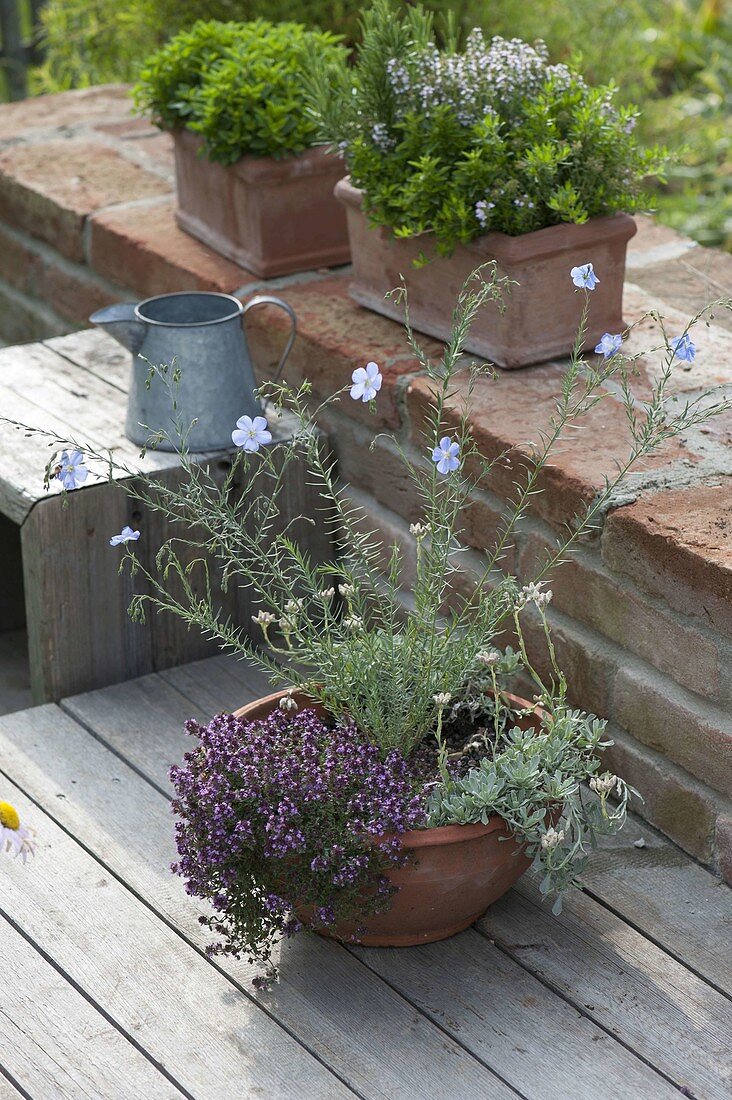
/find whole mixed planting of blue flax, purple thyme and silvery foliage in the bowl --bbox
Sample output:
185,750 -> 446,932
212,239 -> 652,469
9,260 -> 732,972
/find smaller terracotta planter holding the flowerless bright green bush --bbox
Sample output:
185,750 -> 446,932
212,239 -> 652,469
173,130 -> 350,278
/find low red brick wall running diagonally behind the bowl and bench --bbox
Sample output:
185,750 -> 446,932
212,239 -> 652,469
0,87 -> 732,881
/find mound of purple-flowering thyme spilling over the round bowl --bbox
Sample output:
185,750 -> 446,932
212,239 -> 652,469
171,710 -> 425,965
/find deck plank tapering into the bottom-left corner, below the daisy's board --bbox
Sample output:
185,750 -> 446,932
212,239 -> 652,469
0,910 -> 184,1100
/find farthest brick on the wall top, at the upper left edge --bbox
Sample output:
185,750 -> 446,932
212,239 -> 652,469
0,84 -> 131,142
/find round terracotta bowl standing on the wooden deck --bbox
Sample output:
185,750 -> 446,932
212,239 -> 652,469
234,692 -> 533,947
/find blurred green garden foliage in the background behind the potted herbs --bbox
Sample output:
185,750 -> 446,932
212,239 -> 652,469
4,0 -> 732,250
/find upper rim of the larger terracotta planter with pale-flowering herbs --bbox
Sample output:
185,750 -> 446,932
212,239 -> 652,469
335,176 -> 637,263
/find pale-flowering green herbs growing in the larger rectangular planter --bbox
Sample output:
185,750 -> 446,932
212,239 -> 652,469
307,0 -> 665,252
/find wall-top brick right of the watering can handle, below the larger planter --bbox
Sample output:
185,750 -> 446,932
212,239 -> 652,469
247,274 -> 433,430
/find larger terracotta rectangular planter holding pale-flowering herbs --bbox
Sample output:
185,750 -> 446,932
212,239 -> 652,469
336,179 -> 636,369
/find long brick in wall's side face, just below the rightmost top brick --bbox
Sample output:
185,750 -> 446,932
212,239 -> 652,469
521,536 -> 720,696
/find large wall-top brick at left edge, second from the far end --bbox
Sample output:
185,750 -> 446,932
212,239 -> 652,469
0,140 -> 170,261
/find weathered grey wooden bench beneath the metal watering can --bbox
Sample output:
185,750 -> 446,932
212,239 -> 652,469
0,330 -> 328,702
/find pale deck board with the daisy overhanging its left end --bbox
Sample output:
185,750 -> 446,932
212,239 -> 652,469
0,765 -> 351,1100
